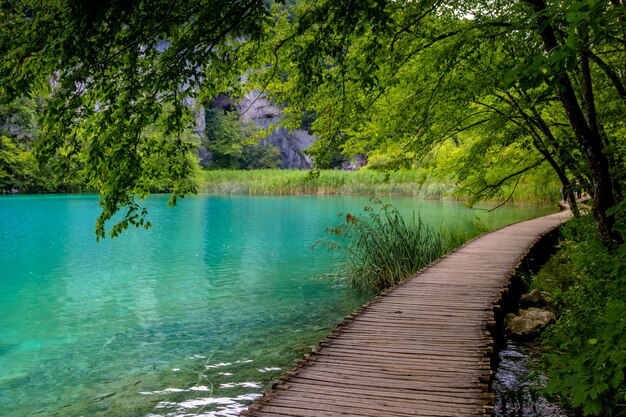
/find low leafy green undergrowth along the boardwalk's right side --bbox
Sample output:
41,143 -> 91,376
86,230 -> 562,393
532,210 -> 626,416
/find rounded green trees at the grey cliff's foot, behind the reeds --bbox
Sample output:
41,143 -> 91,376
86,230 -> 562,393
206,108 -> 280,169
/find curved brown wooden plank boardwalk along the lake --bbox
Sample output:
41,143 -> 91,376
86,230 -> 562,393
241,212 -> 568,417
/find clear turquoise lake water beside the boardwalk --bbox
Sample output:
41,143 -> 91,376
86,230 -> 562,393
0,196 -> 548,417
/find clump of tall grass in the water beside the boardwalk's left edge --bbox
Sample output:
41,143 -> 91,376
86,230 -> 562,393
316,200 -> 466,290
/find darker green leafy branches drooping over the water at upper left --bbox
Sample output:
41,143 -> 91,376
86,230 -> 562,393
0,0 -> 271,237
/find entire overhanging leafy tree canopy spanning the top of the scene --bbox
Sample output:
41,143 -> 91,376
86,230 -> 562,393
0,0 -> 626,246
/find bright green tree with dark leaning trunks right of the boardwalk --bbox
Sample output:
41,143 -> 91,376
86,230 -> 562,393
252,0 -> 626,246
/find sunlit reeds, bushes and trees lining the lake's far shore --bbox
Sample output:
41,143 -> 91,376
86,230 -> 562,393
0,90 -> 560,204
